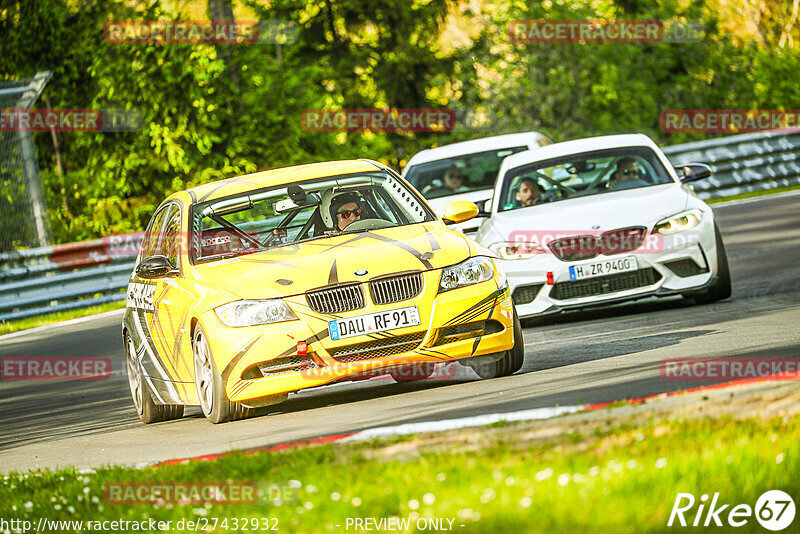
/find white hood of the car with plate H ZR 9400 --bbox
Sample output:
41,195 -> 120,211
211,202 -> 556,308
477,184 -> 689,244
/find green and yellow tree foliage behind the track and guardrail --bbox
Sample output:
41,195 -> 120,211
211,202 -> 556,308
0,0 -> 800,242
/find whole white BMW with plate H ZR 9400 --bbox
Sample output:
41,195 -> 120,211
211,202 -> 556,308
475,134 -> 731,318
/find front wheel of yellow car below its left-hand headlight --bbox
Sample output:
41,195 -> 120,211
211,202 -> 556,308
192,323 -> 256,424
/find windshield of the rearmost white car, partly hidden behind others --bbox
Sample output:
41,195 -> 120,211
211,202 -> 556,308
406,146 -> 528,199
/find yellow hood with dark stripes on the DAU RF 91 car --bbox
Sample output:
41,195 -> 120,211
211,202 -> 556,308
194,221 -> 470,299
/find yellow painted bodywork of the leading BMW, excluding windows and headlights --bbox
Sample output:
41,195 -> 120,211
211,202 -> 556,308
123,160 -> 514,410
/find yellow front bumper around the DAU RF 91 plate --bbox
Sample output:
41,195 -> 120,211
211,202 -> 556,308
200,270 -> 514,402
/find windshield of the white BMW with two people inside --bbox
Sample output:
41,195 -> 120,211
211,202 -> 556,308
500,147 -> 673,215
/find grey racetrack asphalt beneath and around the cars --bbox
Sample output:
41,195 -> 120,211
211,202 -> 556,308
0,193 -> 800,472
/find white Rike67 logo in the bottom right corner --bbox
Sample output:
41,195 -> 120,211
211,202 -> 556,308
667,490 -> 796,531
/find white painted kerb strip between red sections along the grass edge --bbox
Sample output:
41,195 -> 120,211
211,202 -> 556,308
339,406 -> 585,441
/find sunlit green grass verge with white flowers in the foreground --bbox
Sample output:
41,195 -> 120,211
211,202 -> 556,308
0,399 -> 800,534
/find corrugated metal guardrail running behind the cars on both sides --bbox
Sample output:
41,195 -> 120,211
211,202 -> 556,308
0,130 -> 800,321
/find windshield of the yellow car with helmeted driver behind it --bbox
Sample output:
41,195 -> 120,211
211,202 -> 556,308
192,173 -> 435,262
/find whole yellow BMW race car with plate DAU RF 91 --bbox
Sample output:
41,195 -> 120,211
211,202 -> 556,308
122,160 -> 524,423
